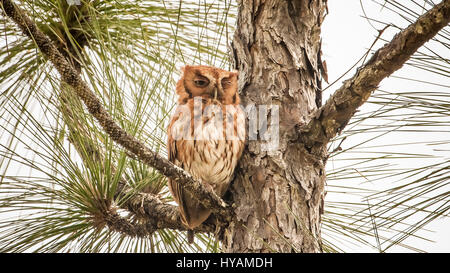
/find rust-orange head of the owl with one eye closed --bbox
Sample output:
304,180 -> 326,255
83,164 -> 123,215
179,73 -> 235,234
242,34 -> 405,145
177,65 -> 240,105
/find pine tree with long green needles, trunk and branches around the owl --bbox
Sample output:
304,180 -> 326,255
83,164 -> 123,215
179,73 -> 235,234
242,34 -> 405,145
0,0 -> 450,252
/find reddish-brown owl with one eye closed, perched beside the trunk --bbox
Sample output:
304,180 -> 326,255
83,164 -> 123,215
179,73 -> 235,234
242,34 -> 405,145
167,65 -> 245,241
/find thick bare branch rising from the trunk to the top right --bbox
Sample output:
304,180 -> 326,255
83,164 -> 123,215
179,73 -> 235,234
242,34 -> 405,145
299,0 -> 450,148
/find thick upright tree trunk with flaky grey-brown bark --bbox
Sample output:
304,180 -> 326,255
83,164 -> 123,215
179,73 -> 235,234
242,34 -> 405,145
223,0 -> 327,252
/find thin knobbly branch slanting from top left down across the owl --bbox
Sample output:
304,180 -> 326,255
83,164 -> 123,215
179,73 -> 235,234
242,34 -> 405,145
0,0 -> 230,218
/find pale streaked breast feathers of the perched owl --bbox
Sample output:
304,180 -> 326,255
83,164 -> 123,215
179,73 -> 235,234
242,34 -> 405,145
172,104 -> 245,195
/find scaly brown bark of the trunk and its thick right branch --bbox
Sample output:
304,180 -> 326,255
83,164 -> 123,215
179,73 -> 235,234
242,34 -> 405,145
224,0 -> 450,252
